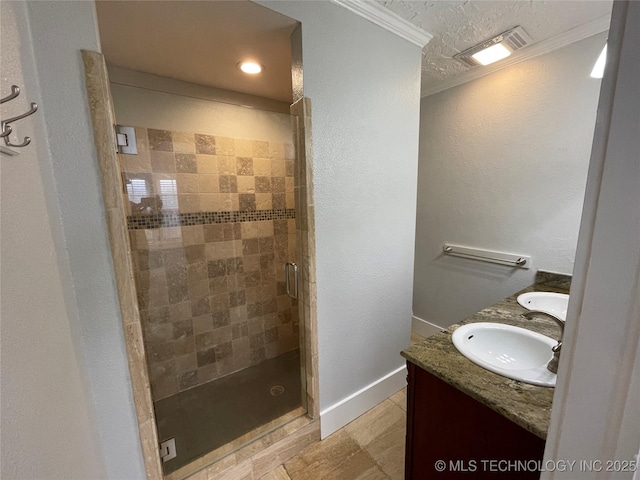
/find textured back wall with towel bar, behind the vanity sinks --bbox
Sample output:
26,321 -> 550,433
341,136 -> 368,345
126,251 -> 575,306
413,23 -> 607,331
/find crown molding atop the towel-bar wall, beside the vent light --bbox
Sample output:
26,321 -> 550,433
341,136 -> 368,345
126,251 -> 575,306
420,15 -> 611,98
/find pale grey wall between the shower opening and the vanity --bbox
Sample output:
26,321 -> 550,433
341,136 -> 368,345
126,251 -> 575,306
258,0 -> 421,413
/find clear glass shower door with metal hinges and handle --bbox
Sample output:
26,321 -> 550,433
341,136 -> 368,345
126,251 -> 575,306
119,104 -> 305,474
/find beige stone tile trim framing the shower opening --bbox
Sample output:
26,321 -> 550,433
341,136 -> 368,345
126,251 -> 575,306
82,50 -> 320,480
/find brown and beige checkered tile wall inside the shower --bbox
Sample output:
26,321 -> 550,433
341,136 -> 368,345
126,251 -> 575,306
120,128 -> 299,400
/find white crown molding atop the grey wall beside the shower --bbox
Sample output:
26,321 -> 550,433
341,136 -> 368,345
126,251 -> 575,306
331,0 -> 433,48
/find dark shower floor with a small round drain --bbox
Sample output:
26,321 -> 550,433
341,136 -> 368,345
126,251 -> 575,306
155,350 -> 301,474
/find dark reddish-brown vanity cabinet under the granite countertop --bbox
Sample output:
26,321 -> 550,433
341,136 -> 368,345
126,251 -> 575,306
405,362 -> 545,480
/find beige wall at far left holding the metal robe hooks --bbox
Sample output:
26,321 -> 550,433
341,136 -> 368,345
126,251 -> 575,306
0,2 -> 107,480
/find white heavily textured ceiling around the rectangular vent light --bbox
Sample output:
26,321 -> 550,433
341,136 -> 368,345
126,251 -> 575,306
377,0 -> 612,90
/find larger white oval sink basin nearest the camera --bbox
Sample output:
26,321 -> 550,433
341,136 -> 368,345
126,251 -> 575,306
451,323 -> 557,387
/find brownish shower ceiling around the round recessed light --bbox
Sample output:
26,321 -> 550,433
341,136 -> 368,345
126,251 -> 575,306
96,1 -> 297,103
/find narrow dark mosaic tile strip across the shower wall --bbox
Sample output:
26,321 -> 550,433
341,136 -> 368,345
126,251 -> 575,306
127,208 -> 296,230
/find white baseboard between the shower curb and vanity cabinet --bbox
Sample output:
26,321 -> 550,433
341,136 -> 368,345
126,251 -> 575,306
320,366 -> 407,438
